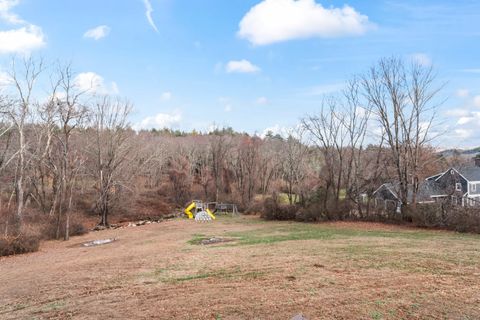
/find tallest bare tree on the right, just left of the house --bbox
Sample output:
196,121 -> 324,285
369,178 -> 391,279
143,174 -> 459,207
362,58 -> 440,212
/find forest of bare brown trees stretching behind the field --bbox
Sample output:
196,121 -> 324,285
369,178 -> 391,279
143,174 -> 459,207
0,57 -> 474,254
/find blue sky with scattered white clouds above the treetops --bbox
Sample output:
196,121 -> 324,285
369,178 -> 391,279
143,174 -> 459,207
0,0 -> 480,147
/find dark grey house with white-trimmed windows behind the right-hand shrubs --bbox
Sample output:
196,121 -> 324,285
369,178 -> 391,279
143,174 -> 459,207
373,155 -> 480,211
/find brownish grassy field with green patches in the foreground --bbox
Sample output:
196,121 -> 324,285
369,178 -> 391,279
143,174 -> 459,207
0,217 -> 480,319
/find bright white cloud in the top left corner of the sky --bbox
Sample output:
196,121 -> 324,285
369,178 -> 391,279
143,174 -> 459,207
0,0 -> 45,54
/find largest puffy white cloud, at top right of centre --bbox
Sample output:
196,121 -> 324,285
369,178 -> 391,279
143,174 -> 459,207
238,0 -> 373,45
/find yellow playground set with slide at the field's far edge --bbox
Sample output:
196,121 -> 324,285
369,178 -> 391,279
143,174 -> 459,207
183,200 -> 238,221
